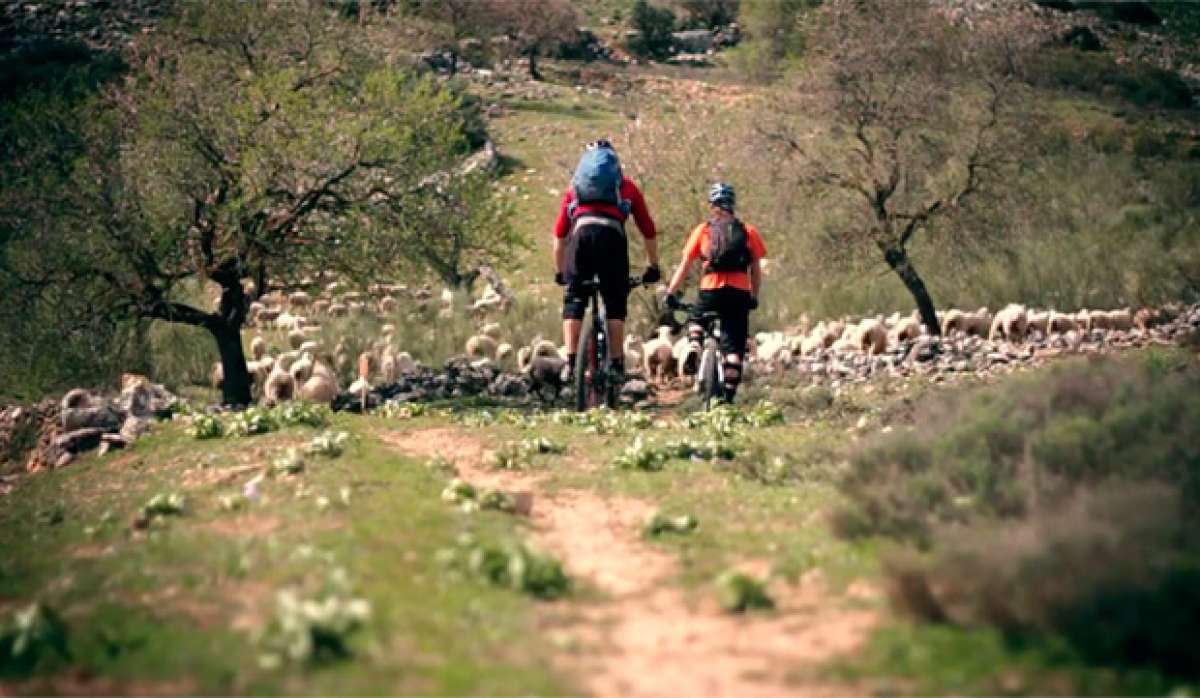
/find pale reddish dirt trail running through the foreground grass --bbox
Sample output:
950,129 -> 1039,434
382,428 -> 877,698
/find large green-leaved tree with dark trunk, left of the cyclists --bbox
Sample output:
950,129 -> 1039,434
0,0 -> 496,404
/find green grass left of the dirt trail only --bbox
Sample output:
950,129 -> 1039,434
0,419 -> 568,694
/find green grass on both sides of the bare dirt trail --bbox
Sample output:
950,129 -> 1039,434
0,357 -> 1195,694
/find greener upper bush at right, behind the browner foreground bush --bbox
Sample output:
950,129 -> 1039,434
834,359 -> 1200,544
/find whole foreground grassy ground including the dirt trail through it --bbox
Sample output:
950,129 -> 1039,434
0,357 -> 1195,694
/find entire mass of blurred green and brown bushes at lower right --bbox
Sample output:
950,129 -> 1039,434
834,353 -> 1200,678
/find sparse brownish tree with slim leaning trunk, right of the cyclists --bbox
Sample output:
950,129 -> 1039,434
761,0 -> 1037,333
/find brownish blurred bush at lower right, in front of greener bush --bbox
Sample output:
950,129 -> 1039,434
886,483 -> 1200,678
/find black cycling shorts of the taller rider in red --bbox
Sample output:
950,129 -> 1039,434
563,224 -> 629,320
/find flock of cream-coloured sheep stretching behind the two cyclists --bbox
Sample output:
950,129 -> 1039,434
212,271 -> 1176,405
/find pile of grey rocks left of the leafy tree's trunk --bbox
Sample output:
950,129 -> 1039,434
25,378 -> 178,471
